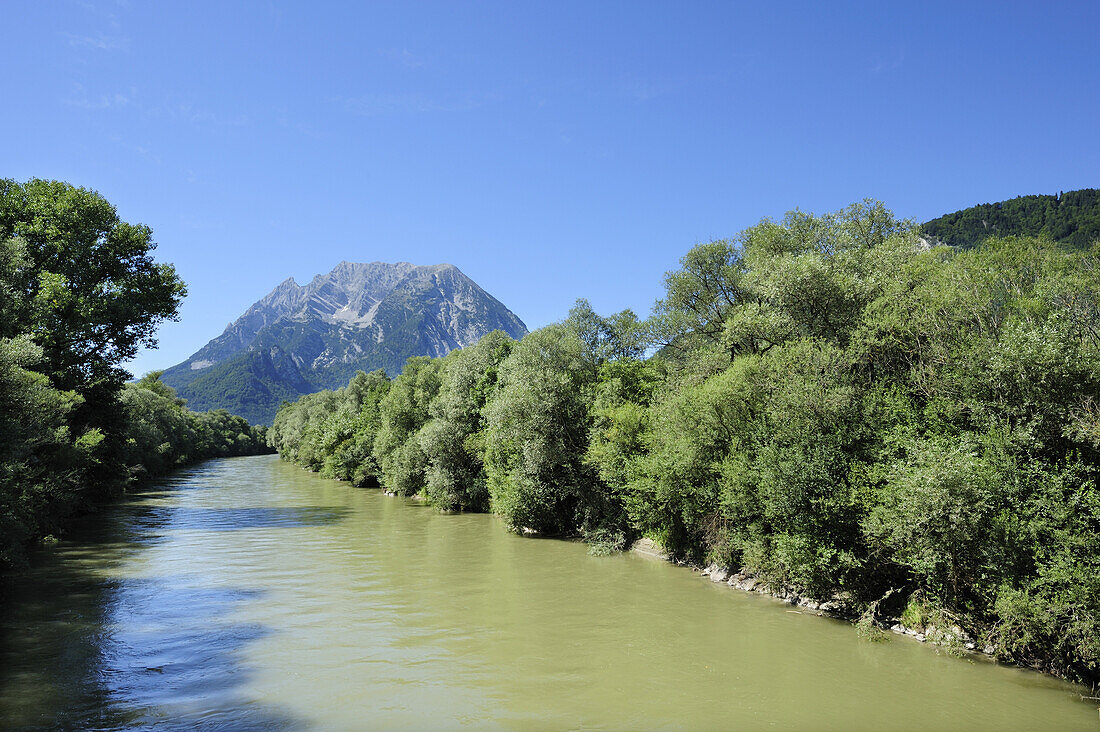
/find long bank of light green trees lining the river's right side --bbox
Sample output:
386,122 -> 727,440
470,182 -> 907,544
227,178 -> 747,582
267,201 -> 1100,680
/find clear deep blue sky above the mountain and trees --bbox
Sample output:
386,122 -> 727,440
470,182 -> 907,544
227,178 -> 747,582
0,0 -> 1100,373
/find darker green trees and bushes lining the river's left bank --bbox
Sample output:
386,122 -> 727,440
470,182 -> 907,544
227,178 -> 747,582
0,181 -> 268,570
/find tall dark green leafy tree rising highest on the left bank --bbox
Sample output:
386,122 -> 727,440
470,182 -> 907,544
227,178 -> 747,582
0,179 -> 186,402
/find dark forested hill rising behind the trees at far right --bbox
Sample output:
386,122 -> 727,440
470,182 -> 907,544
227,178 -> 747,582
922,188 -> 1100,249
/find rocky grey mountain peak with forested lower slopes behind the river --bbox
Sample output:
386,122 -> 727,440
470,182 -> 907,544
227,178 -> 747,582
161,262 -> 527,424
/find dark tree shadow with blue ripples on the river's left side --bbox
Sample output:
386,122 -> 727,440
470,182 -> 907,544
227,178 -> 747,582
0,471 -> 310,730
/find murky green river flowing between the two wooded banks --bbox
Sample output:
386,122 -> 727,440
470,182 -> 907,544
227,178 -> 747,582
0,457 -> 1100,731
